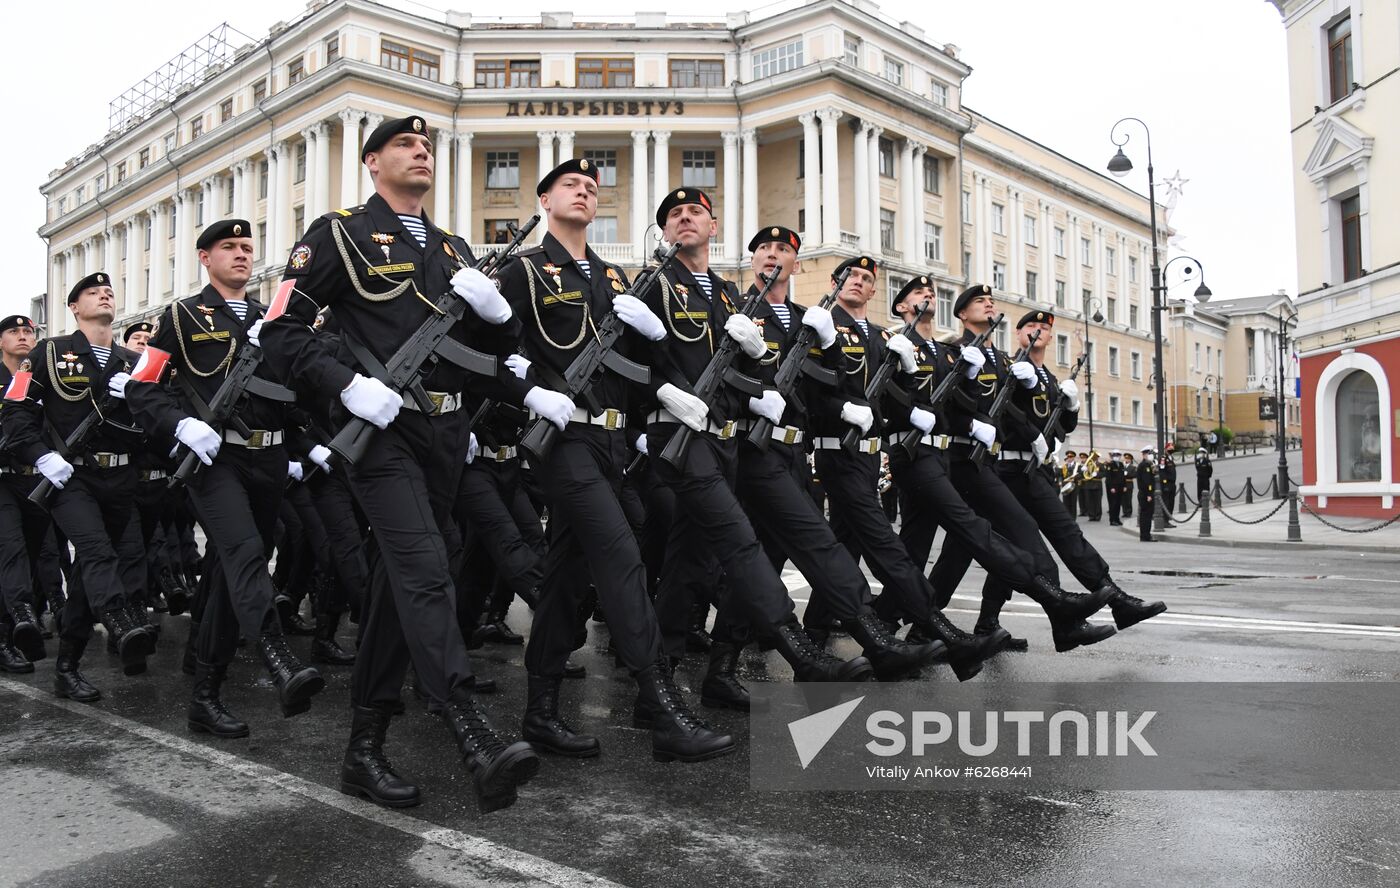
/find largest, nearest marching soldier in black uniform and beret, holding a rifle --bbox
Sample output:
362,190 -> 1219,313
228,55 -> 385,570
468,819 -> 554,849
263,115 -> 539,810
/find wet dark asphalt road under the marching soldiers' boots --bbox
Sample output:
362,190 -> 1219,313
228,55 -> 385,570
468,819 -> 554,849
0,524 -> 1400,888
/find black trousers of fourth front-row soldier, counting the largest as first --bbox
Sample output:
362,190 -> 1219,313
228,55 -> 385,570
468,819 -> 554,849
738,440 -> 871,630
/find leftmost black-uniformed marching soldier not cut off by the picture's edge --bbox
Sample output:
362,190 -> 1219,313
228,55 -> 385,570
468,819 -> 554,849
4,272 -> 154,691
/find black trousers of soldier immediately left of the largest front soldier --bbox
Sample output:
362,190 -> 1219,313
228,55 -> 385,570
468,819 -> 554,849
188,443 -> 287,665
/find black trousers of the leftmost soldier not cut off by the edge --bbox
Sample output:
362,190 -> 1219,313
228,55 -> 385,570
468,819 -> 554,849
49,465 -> 146,641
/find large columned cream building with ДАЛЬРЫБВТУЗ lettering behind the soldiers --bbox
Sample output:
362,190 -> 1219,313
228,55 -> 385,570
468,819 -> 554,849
39,0 -> 1170,450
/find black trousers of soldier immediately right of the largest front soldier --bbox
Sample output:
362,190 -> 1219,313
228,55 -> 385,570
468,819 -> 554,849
525,423 -> 661,678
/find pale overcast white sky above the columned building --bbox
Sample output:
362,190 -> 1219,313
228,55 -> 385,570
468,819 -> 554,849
0,0 -> 1298,314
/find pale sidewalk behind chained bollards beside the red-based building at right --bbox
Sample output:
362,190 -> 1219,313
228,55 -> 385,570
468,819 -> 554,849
1123,499 -> 1400,555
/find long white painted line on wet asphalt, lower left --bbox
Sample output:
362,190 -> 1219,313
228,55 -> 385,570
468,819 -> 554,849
0,678 -> 620,888
